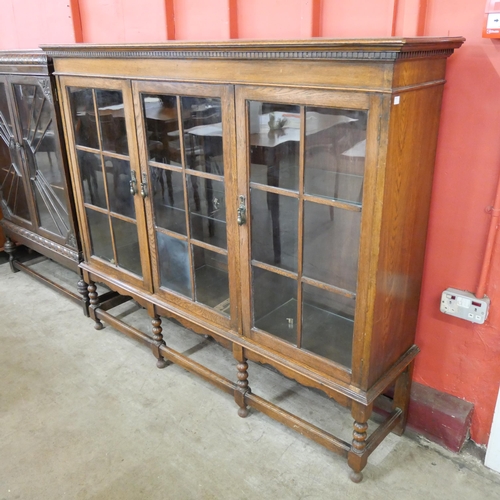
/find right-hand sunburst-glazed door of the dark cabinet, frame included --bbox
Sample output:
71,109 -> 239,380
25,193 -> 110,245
10,76 -> 76,247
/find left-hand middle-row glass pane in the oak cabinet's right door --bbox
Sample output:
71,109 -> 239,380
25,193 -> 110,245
250,189 -> 299,271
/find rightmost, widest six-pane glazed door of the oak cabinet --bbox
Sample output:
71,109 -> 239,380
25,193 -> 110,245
236,87 -> 374,382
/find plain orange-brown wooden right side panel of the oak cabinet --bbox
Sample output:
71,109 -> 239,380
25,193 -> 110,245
364,85 -> 443,387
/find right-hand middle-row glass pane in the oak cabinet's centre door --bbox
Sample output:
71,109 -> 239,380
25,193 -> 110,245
186,175 -> 227,248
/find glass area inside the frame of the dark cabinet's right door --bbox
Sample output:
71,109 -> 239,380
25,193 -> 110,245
14,85 -> 69,236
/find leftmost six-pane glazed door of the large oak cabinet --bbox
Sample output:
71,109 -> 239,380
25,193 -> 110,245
60,77 -> 150,289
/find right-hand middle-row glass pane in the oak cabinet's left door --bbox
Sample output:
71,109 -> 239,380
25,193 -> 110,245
103,156 -> 135,219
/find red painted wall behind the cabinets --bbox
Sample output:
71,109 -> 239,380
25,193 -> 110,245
0,0 -> 500,444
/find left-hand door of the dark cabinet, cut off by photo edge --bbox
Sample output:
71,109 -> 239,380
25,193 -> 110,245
0,76 -> 34,225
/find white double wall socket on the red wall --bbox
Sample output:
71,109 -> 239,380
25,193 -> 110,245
439,288 -> 490,325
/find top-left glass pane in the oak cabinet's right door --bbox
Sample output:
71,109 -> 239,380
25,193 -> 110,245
248,101 -> 300,191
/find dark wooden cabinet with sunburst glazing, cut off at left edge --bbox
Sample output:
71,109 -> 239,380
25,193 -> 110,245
0,50 -> 87,310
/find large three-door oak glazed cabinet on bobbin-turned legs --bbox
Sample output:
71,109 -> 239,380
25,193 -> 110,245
45,38 -> 463,481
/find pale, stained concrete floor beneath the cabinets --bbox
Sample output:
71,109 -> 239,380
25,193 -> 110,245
0,256 -> 500,500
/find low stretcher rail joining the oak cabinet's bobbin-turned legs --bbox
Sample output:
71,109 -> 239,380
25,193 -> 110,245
90,302 -> 405,483
